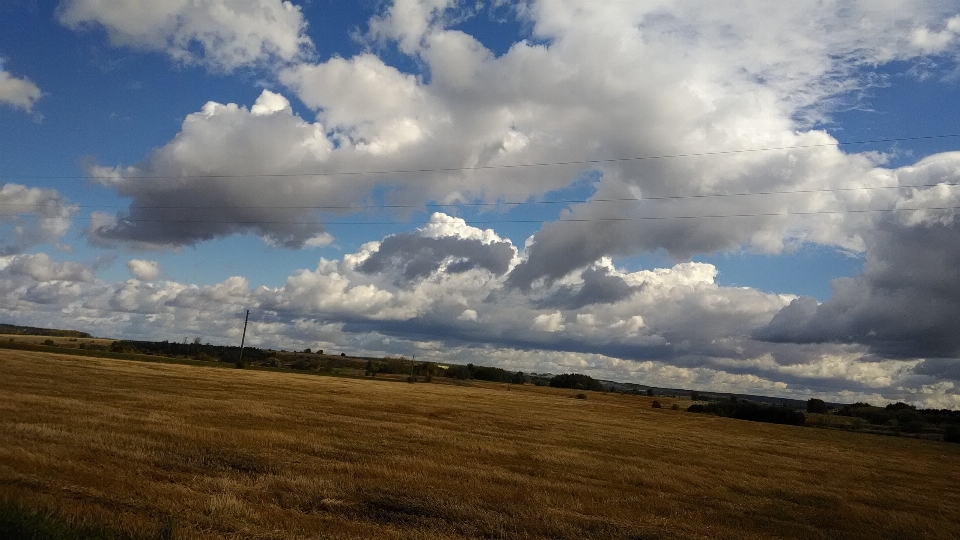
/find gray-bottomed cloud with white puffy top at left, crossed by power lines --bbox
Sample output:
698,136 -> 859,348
88,90 -> 342,249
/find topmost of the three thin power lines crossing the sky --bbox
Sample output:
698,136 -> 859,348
7,133 -> 960,180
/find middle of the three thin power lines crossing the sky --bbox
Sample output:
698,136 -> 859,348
0,182 -> 960,210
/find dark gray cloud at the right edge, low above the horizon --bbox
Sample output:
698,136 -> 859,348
754,215 -> 960,358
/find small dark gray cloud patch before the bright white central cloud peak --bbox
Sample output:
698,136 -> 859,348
358,233 -> 515,281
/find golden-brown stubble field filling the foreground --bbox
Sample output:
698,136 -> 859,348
0,350 -> 960,539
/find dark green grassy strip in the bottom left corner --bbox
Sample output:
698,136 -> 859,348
0,501 -> 174,540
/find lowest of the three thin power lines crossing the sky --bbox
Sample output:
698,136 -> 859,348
69,206 -> 960,226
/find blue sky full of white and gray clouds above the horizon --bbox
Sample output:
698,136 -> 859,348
0,0 -> 960,409
